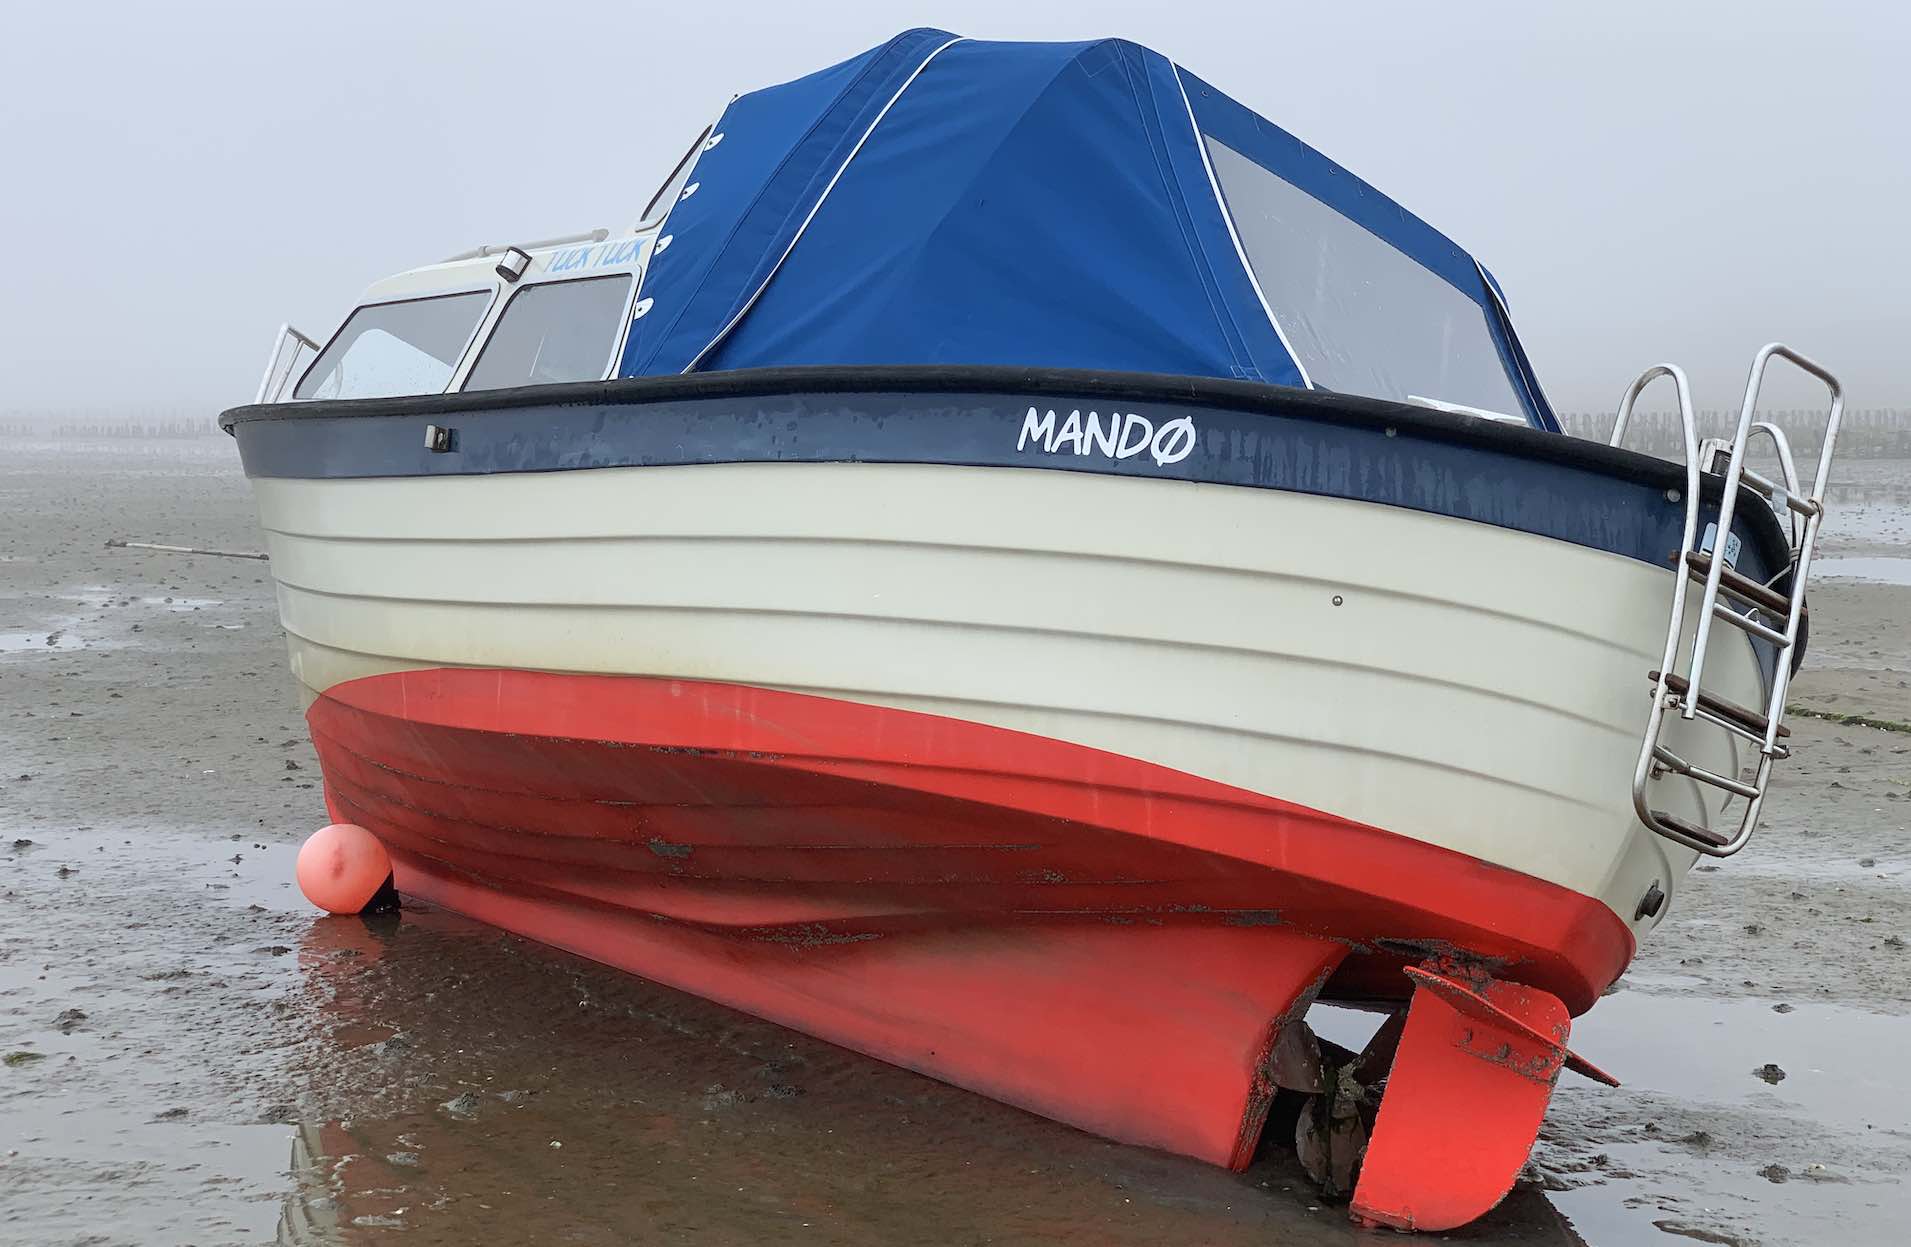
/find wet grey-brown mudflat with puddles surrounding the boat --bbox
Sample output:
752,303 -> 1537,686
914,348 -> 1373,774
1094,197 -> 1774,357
0,437 -> 1911,1247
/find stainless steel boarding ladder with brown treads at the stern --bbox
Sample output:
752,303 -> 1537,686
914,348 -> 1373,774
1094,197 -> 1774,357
1611,342 -> 1844,857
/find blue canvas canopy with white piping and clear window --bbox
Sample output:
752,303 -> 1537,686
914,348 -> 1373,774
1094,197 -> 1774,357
619,31 -> 1557,428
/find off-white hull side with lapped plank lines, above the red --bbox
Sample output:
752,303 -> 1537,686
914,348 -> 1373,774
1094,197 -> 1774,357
254,464 -> 1762,930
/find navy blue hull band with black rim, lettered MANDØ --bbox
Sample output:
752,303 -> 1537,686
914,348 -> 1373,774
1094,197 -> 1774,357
222,367 -> 1789,581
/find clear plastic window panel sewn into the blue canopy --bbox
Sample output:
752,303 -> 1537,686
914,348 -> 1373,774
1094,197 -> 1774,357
1206,137 -> 1525,424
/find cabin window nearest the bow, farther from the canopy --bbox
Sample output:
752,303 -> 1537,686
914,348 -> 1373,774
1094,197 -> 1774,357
292,290 -> 491,399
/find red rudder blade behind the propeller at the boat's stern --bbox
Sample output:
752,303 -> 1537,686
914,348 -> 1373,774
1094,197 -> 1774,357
1351,964 -> 1619,1230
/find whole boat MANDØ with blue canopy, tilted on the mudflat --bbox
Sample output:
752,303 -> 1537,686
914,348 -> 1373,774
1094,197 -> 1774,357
222,31 -> 1842,1230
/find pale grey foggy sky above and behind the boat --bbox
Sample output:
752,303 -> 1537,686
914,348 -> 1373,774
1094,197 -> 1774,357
0,0 -> 1911,416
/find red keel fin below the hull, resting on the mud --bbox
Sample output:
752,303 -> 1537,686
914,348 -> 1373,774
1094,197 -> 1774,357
394,850 -> 1345,1171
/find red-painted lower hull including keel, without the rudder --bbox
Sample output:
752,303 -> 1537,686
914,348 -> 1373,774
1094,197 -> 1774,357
310,670 -> 1632,1167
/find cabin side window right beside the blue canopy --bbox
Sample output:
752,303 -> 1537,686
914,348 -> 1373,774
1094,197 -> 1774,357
464,273 -> 631,390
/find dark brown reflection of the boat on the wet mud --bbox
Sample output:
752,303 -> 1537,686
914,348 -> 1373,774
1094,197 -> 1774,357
269,907 -> 1580,1245
